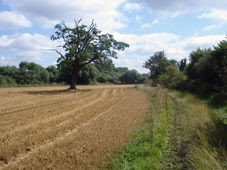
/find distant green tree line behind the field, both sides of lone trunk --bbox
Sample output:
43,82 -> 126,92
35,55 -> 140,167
0,62 -> 148,87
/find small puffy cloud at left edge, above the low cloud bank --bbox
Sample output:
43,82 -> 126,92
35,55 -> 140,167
0,11 -> 32,29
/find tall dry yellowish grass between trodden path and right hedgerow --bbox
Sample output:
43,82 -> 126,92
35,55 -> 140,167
169,92 -> 227,170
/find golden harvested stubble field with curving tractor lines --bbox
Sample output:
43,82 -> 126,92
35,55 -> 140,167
0,85 -> 149,169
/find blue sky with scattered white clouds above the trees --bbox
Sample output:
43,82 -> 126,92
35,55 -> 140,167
0,0 -> 227,73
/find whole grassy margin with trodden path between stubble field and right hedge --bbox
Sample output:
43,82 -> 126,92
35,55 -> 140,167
108,87 -> 227,170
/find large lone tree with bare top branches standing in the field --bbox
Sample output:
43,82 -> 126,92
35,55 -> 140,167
51,20 -> 129,89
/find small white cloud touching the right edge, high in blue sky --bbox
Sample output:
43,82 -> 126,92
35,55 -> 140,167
198,9 -> 227,23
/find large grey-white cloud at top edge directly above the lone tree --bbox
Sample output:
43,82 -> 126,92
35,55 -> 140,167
6,0 -> 127,32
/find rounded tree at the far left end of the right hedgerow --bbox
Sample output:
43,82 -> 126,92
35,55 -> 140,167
144,51 -> 170,80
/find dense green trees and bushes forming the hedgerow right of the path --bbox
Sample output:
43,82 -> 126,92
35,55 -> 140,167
144,40 -> 227,96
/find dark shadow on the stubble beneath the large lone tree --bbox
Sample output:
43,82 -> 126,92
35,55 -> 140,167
20,89 -> 91,95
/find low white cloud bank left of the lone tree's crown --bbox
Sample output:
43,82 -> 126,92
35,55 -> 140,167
0,33 -> 57,66
